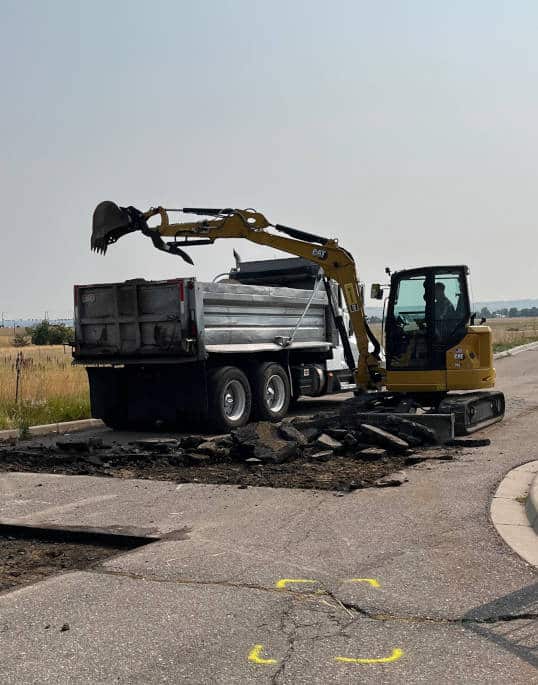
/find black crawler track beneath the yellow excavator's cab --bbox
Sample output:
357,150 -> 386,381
438,391 -> 505,435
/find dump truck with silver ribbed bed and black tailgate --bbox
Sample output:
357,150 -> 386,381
73,258 -> 357,431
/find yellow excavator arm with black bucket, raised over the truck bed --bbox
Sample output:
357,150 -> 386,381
91,202 -> 383,391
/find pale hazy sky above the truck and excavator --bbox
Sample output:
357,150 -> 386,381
0,0 -> 538,318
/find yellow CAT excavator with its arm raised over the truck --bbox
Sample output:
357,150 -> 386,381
91,201 -> 505,435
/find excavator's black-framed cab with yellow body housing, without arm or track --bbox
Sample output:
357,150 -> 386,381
385,265 -> 495,393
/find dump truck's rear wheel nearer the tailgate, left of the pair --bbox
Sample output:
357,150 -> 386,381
208,366 -> 252,433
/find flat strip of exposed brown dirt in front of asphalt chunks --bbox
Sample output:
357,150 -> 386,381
0,445 -> 455,491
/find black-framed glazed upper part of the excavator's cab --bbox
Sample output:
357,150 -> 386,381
386,266 -> 470,370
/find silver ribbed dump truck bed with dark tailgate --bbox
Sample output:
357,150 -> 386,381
74,278 -> 337,363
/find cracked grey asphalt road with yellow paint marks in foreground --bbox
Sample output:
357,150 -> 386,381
0,351 -> 538,685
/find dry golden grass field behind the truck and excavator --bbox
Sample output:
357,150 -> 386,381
0,318 -> 538,431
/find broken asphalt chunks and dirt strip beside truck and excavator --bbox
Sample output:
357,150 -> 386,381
0,400 -> 489,490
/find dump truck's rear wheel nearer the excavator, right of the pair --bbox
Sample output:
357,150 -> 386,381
253,362 -> 291,421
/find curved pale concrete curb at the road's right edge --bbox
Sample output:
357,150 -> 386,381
490,461 -> 538,568
